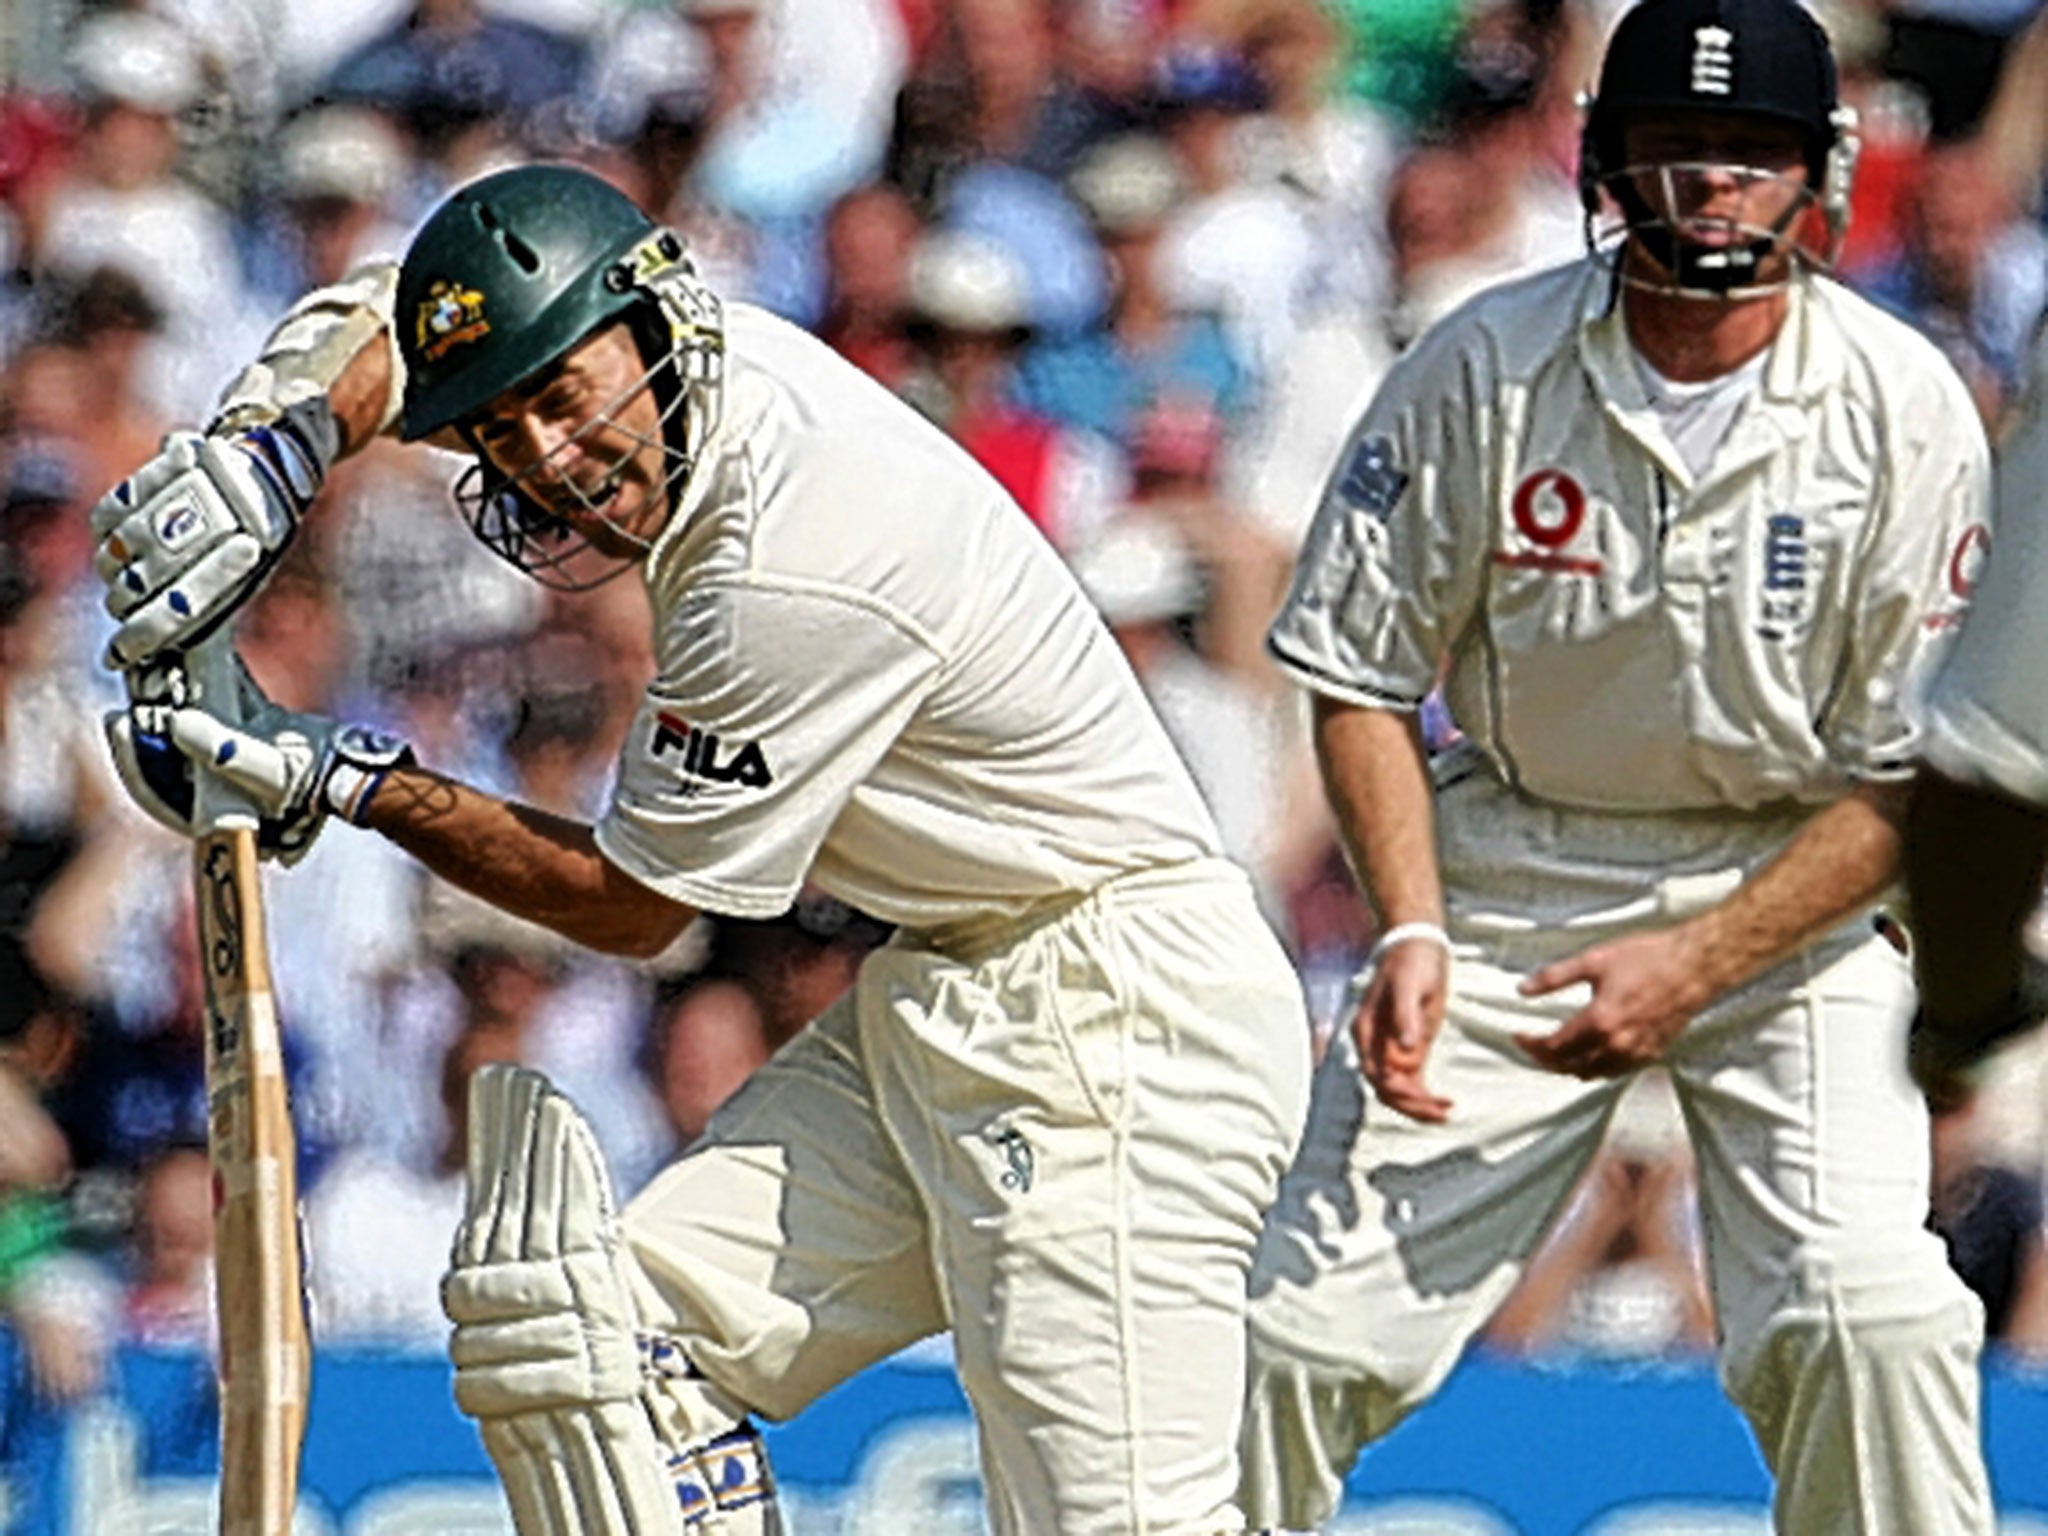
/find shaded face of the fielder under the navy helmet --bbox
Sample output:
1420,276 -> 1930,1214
1622,113 -> 1812,259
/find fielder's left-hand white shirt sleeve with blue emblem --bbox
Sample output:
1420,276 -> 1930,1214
1268,340 -> 1485,711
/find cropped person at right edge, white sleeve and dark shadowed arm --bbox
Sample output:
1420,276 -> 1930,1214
1907,330 -> 2048,1104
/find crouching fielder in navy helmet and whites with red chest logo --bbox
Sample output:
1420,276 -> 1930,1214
1245,0 -> 1993,1536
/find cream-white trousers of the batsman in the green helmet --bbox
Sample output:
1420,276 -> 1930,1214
625,860 -> 1309,1536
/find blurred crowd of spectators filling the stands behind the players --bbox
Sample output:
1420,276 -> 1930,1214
0,0 -> 2048,1397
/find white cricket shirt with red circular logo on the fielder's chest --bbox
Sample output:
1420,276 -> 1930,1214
1270,260 -> 1989,811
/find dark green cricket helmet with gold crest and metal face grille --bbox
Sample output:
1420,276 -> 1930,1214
393,164 -> 725,588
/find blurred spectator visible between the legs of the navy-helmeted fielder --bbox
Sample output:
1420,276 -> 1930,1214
1483,1075 -> 1714,1360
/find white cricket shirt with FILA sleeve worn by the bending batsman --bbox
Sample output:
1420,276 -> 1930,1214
598,303 -> 1219,934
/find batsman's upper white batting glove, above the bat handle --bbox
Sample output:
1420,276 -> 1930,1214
92,399 -> 340,670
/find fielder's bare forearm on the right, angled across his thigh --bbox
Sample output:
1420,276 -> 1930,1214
1688,784 -> 1909,995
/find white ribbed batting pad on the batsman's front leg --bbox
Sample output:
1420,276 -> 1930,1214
440,1065 -> 778,1536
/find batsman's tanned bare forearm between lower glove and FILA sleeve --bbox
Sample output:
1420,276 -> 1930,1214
365,768 -> 696,958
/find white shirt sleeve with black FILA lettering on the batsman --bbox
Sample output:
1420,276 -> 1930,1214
596,584 -> 940,918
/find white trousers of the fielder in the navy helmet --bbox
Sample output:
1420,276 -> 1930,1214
1243,780 -> 1993,1536
